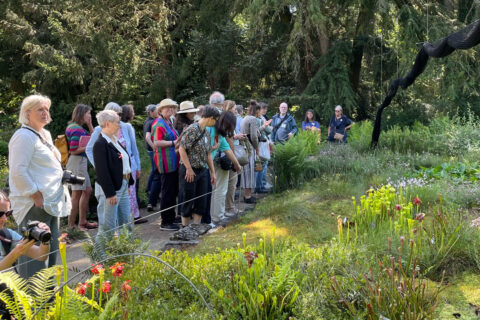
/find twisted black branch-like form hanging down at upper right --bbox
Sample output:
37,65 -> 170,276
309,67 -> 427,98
371,20 -> 480,148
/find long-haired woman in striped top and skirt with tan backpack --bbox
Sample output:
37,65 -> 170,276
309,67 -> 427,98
65,104 -> 97,231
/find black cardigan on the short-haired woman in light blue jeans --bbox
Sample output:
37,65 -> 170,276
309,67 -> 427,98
93,135 -> 135,198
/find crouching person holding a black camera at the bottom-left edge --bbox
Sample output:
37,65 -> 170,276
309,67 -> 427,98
0,191 -> 50,271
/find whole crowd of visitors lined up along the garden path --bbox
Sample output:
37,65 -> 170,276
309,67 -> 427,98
0,92 -> 352,277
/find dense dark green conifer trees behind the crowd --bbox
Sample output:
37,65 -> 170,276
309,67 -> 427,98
0,0 -> 480,140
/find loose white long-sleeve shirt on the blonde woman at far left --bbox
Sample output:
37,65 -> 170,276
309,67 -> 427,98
8,127 -> 72,224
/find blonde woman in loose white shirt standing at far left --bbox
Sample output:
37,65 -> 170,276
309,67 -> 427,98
8,95 -> 71,278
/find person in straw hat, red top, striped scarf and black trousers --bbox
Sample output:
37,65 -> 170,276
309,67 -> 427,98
149,99 -> 180,231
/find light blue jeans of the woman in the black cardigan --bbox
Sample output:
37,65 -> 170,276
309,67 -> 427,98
96,180 -> 132,258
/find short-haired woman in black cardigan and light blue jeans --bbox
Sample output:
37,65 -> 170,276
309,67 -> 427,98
93,110 -> 134,258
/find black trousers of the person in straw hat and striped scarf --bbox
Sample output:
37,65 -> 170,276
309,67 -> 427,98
160,170 -> 178,225
